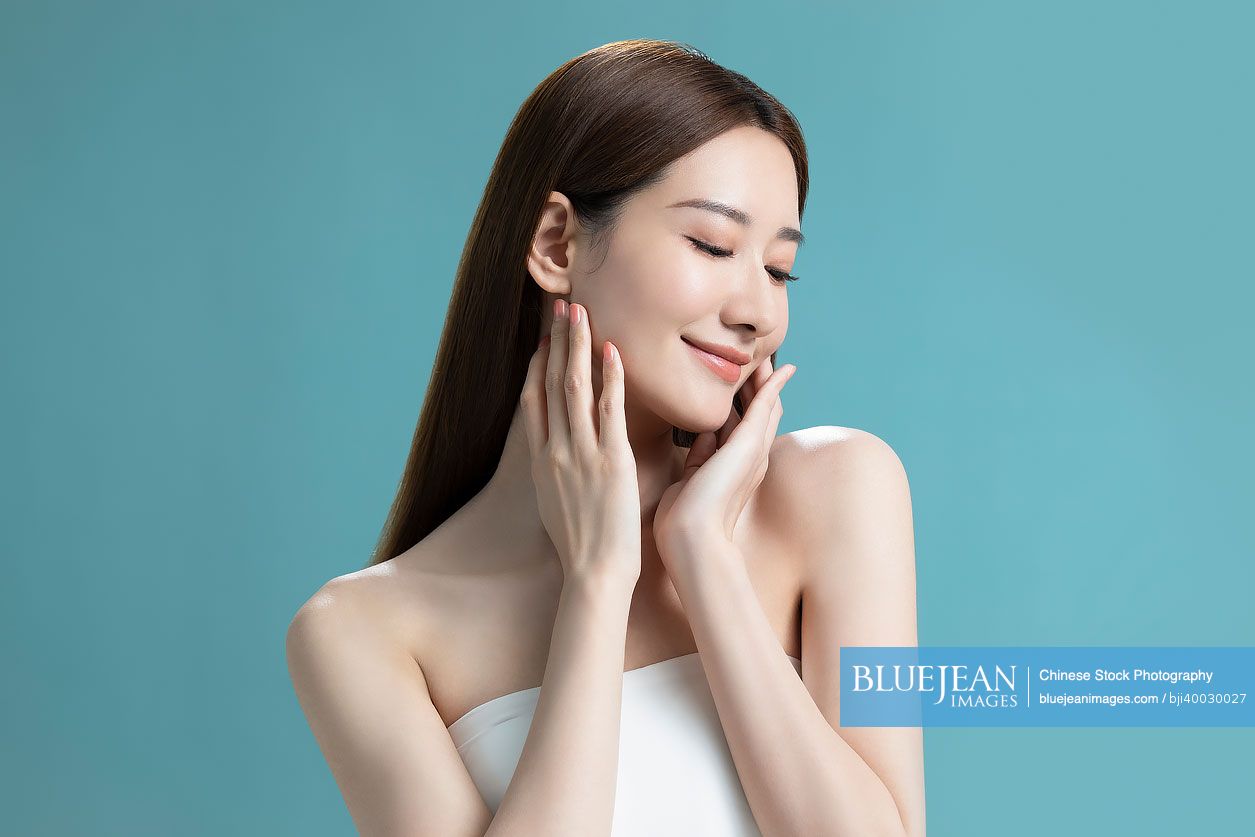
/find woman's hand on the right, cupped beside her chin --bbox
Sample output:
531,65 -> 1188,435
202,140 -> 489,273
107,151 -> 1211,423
654,358 -> 797,563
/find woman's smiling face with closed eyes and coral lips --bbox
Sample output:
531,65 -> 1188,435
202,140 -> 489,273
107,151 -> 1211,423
570,125 -> 799,432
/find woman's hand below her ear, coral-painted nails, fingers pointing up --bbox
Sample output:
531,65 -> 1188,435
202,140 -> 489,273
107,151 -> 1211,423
520,300 -> 641,590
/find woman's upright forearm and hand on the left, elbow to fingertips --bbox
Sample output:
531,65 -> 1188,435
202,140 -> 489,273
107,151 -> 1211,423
488,299 -> 641,837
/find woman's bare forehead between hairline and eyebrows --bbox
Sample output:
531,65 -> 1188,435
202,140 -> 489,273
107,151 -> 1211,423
639,125 -> 799,228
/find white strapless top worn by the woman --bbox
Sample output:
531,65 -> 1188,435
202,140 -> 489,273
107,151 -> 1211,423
449,653 -> 802,837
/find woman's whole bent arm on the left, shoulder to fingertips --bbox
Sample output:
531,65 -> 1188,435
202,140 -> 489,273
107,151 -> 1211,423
287,300 -> 641,837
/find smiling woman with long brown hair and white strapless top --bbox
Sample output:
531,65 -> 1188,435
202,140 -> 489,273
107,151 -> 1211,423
287,40 -> 924,837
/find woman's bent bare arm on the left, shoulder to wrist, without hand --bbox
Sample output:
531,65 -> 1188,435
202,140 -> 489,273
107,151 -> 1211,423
287,569 -> 631,837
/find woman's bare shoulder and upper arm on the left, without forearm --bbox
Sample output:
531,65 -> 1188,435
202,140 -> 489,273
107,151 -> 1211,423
286,552 -> 491,834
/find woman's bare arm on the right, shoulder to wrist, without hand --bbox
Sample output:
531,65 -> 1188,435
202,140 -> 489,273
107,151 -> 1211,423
668,432 -> 924,837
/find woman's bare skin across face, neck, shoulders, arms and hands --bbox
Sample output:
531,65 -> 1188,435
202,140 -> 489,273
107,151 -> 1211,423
287,128 -> 924,837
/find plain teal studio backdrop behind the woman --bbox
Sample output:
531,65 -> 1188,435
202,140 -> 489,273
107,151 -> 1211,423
0,0 -> 1255,837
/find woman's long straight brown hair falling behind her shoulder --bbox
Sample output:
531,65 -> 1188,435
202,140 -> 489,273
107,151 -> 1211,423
366,39 -> 808,566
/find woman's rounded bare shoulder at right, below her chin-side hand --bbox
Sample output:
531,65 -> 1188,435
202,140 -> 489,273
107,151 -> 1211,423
762,424 -> 910,557
